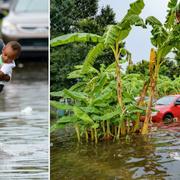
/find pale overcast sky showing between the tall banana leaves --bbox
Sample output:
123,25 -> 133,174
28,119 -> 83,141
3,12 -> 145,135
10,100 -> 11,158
99,0 -> 168,65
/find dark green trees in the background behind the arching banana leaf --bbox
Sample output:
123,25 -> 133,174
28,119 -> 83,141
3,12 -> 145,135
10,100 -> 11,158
50,0 -> 115,91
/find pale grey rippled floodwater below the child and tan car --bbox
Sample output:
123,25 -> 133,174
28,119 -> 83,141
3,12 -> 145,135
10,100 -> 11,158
0,62 -> 48,180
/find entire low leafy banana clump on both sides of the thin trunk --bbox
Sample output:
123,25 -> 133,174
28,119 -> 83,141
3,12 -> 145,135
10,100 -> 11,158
51,63 -> 149,143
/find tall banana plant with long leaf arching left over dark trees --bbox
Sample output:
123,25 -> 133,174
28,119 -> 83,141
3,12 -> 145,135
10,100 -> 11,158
51,0 -> 145,133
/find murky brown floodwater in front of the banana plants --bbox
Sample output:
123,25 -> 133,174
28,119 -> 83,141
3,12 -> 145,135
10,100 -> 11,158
51,123 -> 180,180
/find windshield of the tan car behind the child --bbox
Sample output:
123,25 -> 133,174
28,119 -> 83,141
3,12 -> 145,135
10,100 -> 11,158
14,0 -> 48,13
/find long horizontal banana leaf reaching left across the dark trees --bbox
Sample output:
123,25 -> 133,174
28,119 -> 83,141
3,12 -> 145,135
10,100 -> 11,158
50,33 -> 102,47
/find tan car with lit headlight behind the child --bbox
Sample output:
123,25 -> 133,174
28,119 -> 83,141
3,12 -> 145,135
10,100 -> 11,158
1,0 -> 48,57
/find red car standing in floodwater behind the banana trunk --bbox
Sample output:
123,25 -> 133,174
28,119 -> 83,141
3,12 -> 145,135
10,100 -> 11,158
151,94 -> 180,123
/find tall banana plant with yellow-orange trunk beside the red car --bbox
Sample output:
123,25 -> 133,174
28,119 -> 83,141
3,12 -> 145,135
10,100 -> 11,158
142,0 -> 180,134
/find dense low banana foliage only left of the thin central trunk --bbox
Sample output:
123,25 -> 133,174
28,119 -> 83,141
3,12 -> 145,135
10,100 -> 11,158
51,64 -> 115,143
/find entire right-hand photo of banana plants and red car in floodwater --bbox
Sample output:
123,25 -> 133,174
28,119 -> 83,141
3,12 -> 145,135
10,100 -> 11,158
50,0 -> 180,180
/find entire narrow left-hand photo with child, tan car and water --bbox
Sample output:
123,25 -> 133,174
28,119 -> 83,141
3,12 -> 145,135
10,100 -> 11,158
0,0 -> 49,180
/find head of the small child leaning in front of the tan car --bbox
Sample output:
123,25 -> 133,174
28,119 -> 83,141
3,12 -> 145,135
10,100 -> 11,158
2,41 -> 21,63
